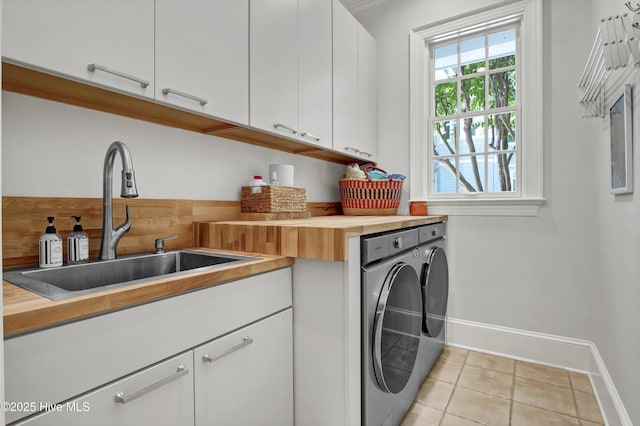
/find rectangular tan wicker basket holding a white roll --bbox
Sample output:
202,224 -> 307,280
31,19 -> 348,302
240,185 -> 307,213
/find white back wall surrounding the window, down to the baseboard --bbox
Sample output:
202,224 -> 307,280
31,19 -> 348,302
358,0 -> 596,338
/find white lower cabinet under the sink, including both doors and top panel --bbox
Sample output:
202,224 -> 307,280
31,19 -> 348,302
4,268 -> 293,426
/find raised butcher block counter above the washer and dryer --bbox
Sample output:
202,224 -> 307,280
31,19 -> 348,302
194,216 -> 447,262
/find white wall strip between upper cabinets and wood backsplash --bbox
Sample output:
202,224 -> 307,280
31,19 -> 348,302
2,92 -> 344,201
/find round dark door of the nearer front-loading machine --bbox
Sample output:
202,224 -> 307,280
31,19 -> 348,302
372,263 -> 422,394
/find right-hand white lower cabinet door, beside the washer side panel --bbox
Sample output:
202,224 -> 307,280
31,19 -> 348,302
194,309 -> 293,426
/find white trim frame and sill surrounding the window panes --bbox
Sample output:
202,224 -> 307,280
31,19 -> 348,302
409,0 -> 545,216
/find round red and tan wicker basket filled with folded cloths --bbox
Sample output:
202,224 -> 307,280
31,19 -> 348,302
338,166 -> 403,216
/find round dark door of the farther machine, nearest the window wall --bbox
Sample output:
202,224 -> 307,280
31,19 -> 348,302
422,247 -> 449,337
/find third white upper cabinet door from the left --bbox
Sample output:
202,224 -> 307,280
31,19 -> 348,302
249,0 -> 298,138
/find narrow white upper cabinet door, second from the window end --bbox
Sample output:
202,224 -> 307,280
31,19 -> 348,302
333,0 -> 359,155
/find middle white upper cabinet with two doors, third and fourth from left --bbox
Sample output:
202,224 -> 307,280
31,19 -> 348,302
249,0 -> 333,148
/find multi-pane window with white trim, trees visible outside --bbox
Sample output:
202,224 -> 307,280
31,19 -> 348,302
410,0 -> 543,215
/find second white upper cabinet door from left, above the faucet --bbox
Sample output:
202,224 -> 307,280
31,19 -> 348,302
155,0 -> 249,124
